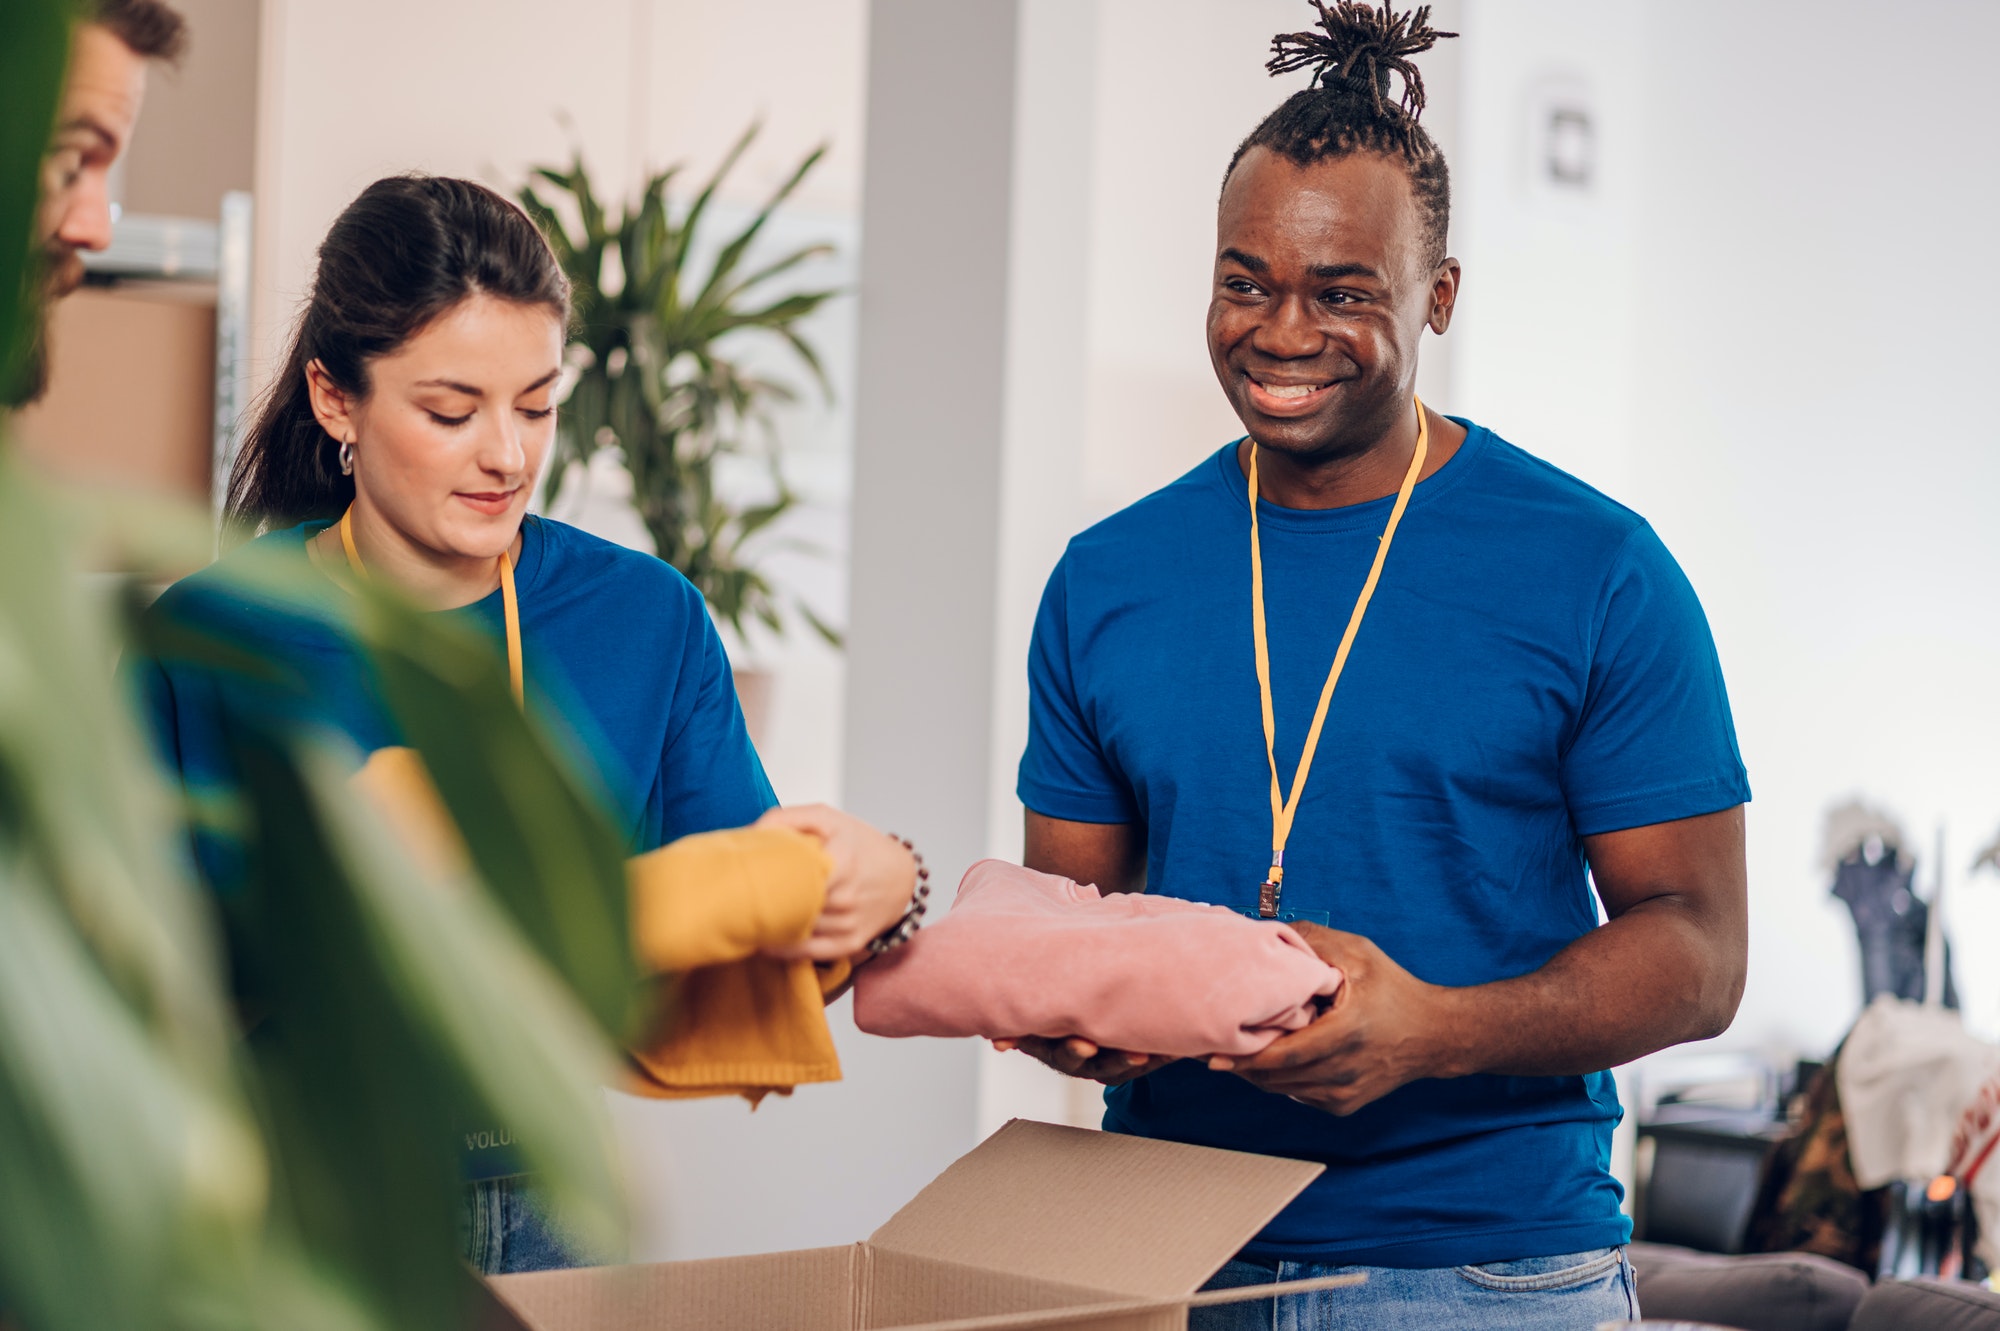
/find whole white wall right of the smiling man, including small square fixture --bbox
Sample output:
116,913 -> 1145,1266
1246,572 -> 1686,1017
1452,0 -> 2000,1055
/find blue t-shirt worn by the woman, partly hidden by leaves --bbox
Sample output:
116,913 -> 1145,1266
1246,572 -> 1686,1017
138,518 -> 778,891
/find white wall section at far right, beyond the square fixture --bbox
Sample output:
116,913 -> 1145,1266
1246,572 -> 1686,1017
1634,0 -> 2000,1051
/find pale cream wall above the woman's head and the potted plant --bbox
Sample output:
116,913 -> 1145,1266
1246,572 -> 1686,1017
258,0 -> 868,365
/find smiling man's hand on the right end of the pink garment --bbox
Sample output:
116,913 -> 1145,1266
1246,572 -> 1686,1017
1208,923 -> 1464,1115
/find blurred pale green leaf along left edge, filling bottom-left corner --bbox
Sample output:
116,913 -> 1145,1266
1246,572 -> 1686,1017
0,445 -> 268,1331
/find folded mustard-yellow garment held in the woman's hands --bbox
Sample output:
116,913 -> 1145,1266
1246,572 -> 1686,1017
354,747 -> 848,1105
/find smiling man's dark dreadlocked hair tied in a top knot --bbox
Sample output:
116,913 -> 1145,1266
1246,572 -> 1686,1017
1222,0 -> 1458,264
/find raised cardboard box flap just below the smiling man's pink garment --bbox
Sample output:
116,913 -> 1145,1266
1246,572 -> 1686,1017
870,1119 -> 1322,1299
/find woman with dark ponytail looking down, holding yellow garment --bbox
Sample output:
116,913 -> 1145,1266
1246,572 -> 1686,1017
138,176 -> 920,1271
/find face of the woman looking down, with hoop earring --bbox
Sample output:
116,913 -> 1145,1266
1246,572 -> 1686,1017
314,296 -> 562,560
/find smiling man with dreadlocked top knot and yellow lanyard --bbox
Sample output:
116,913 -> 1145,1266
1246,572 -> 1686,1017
1004,4 -> 1750,1331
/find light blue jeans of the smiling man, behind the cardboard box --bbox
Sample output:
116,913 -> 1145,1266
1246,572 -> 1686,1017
1188,1247 -> 1638,1331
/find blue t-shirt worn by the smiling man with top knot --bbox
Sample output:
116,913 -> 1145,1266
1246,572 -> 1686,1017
1020,424 -> 1750,1267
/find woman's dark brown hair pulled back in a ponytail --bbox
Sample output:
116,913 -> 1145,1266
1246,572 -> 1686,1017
226,176 -> 570,532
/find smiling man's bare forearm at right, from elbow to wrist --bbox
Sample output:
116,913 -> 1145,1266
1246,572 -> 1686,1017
1436,895 -> 1744,1077
